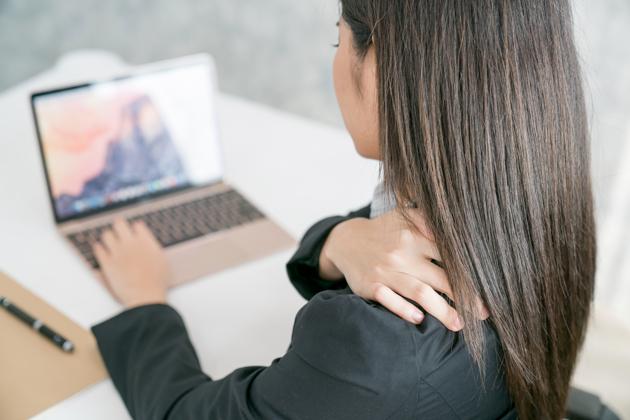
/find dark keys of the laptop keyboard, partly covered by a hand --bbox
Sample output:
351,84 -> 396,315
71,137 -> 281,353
68,190 -> 264,269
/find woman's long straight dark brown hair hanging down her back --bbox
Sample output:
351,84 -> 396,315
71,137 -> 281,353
341,0 -> 596,419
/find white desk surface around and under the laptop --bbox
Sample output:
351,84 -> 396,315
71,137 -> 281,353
0,51 -> 378,420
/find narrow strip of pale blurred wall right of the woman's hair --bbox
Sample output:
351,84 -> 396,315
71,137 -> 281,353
573,0 -> 630,213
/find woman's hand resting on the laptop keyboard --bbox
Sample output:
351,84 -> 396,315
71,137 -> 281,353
94,219 -> 171,308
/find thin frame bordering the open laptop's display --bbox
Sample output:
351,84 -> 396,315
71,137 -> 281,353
30,55 -> 223,224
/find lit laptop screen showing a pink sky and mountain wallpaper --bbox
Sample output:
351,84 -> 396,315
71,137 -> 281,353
32,60 -> 223,222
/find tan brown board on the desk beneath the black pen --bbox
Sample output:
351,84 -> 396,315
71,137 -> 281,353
0,272 -> 107,420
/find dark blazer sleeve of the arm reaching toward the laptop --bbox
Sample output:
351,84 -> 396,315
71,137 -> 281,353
93,292 -> 415,420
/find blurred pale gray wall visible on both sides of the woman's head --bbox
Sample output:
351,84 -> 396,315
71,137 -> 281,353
0,0 -> 630,306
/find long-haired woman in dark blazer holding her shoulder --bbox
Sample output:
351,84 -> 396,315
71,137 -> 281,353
94,0 -> 595,419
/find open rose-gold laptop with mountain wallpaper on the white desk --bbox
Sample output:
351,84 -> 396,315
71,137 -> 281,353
31,55 -> 295,286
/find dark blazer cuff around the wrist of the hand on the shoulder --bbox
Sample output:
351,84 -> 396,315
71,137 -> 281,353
286,205 -> 370,300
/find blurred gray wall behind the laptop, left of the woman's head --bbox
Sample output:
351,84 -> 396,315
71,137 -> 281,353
0,0 -> 341,124
